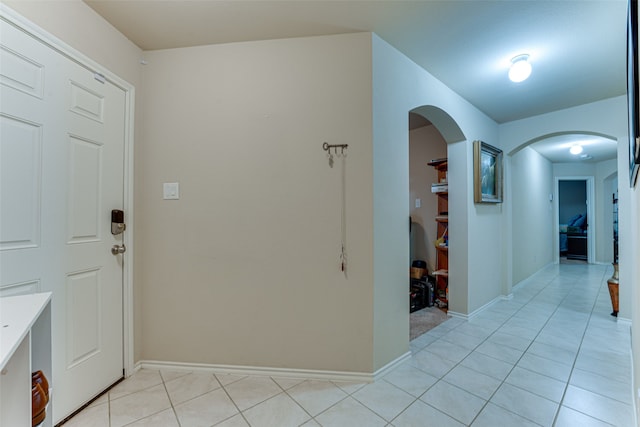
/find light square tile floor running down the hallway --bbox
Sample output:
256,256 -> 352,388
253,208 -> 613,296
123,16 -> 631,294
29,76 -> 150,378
65,265 -> 635,427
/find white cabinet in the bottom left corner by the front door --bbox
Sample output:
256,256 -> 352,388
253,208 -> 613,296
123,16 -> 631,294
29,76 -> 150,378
0,292 -> 54,427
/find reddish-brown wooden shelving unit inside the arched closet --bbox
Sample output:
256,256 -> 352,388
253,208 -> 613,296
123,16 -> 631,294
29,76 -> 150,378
429,158 -> 449,310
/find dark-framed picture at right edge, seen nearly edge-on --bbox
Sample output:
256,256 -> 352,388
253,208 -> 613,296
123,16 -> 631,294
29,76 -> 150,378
627,0 -> 640,187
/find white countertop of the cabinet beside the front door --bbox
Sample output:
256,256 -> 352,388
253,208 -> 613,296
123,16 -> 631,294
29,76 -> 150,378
0,292 -> 51,371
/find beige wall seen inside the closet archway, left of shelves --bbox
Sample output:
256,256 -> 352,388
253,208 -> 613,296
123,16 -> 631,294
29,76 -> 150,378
409,125 -> 447,272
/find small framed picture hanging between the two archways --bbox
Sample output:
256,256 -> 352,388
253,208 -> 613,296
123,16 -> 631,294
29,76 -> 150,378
473,141 -> 502,203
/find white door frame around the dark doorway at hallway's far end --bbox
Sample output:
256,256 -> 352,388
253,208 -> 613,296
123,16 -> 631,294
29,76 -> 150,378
553,176 -> 596,264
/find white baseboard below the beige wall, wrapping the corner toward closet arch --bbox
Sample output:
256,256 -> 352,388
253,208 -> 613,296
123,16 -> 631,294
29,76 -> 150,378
135,352 -> 411,383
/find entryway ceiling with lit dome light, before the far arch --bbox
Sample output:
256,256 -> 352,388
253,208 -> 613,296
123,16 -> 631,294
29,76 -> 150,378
84,0 -> 627,163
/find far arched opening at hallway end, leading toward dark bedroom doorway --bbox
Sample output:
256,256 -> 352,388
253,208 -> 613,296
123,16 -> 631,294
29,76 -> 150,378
508,131 -> 617,284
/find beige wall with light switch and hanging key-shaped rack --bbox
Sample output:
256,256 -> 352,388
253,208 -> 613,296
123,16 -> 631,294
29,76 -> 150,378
136,33 -> 373,372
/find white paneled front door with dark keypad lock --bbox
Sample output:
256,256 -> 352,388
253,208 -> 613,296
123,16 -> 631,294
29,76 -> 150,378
0,20 -> 126,422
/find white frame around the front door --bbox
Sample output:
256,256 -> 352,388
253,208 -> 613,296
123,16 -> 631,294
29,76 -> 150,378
0,3 -> 135,377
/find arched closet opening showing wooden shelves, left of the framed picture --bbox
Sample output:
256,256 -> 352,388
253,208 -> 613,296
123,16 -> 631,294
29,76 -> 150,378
408,106 -> 464,339
